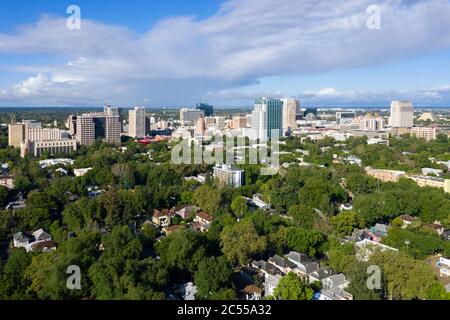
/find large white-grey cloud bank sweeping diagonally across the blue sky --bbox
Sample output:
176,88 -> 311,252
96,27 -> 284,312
0,0 -> 450,105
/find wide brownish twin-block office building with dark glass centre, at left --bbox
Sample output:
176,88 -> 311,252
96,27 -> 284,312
77,107 -> 121,146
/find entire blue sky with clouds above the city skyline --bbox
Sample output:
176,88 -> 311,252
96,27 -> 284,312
0,0 -> 450,107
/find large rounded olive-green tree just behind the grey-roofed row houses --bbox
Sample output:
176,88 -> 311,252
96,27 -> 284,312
220,220 -> 266,265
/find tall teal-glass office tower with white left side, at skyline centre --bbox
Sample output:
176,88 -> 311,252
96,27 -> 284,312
252,97 -> 283,141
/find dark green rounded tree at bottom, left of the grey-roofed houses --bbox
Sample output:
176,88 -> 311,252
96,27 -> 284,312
194,257 -> 232,298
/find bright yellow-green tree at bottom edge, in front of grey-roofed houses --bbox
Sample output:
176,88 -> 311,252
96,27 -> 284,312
273,272 -> 314,300
